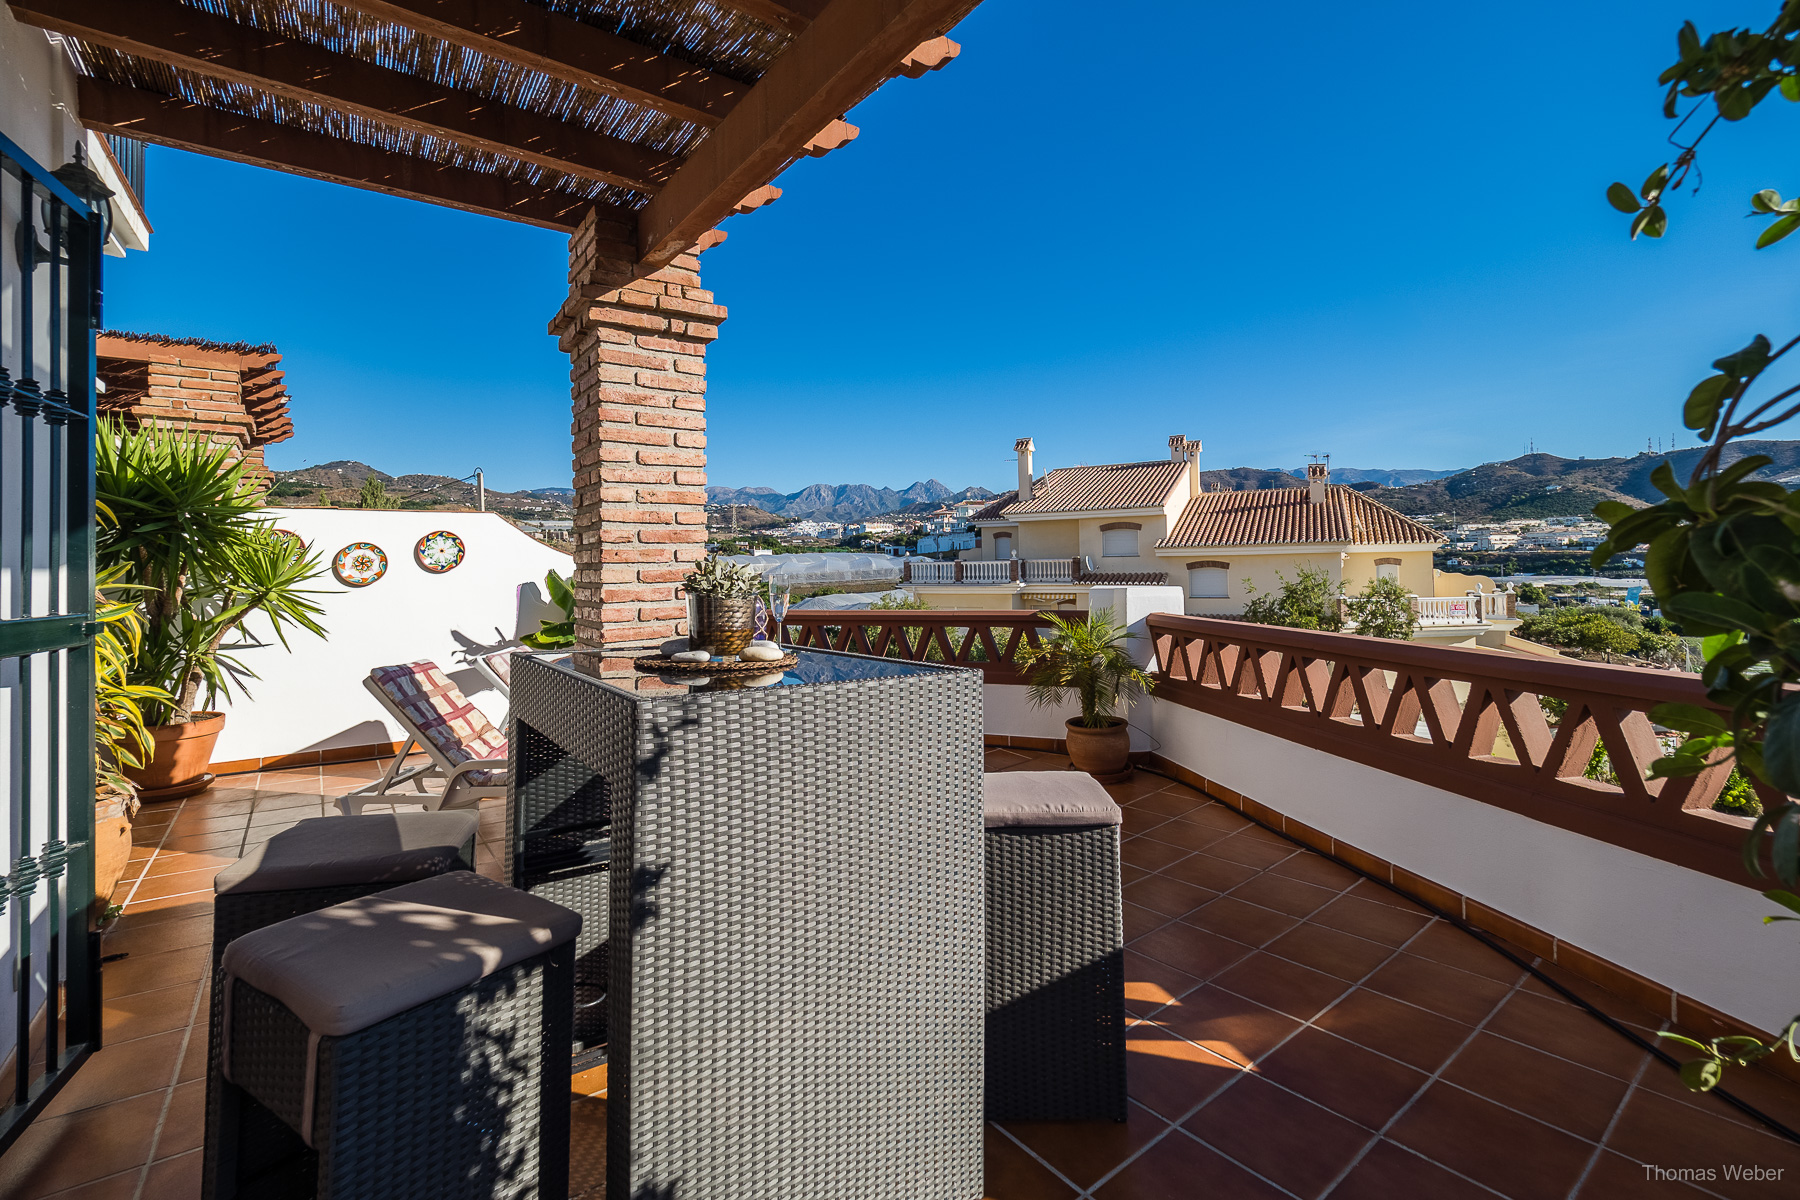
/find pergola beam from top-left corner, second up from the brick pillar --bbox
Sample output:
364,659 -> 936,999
11,0 -> 680,193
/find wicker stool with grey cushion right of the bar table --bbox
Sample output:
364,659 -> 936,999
981,772 -> 1125,1121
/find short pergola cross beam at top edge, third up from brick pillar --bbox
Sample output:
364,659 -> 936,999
335,0 -> 741,126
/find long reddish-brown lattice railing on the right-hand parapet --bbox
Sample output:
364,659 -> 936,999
1147,613 -> 1777,883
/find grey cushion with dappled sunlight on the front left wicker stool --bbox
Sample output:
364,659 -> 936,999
225,874 -> 581,1043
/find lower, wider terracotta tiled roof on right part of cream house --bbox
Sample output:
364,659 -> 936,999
1157,484 -> 1444,549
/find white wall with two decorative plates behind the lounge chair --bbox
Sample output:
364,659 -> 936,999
212,507 -> 574,763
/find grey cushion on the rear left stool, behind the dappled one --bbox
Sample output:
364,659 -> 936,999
212,811 -> 481,896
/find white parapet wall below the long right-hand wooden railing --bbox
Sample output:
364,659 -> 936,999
1152,687 -> 1800,1029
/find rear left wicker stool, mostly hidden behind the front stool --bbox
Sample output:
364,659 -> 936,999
202,811 -> 481,1200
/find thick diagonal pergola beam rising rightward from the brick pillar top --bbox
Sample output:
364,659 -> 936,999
637,0 -> 976,270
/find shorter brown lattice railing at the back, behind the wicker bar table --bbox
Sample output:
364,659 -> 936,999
781,608 -> 1087,684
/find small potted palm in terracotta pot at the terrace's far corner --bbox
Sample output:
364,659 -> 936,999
1019,608 -> 1156,783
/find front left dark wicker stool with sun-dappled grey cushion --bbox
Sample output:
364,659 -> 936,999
209,871 -> 581,1200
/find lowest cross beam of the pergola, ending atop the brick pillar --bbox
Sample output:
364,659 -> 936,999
77,79 -> 612,234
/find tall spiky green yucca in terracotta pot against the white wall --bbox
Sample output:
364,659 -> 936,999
94,423 -> 324,801
